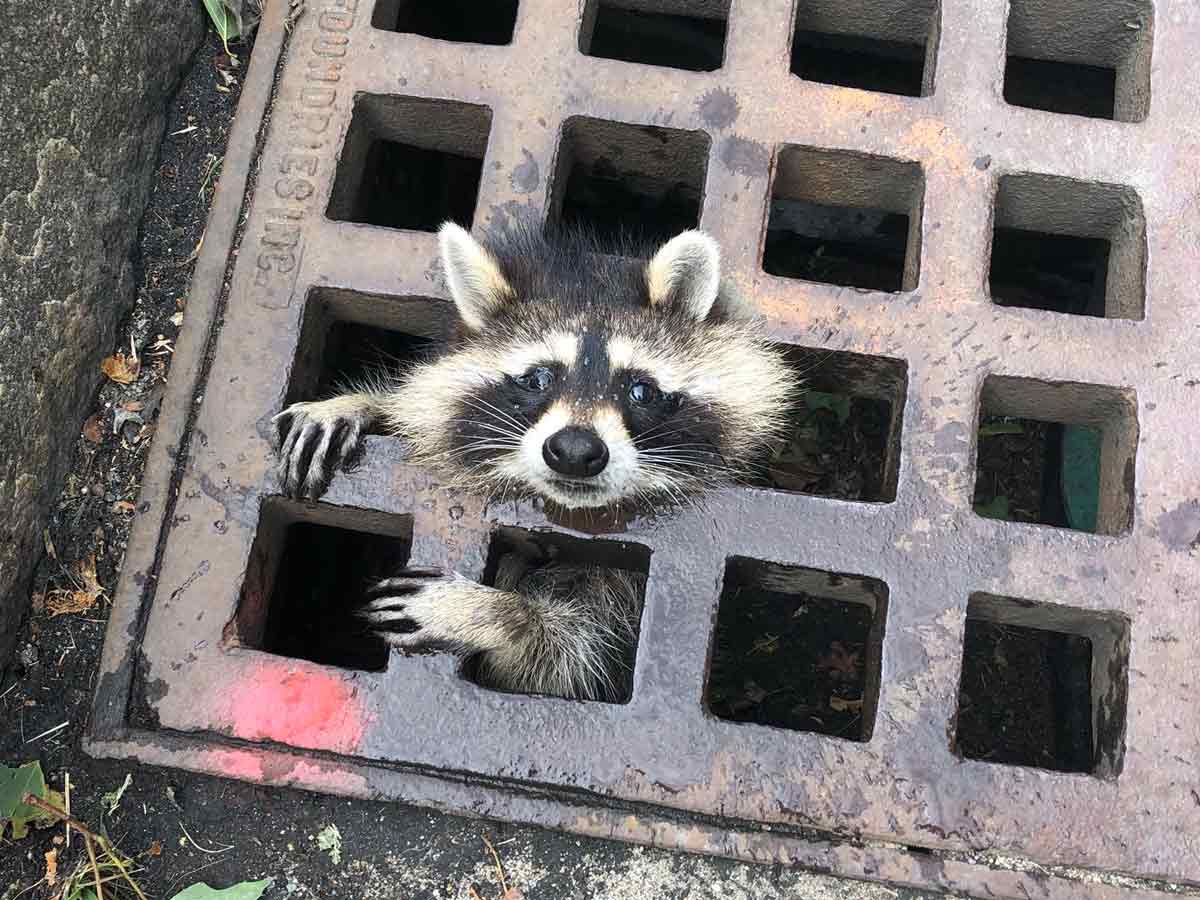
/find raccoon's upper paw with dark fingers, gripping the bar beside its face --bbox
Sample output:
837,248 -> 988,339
271,397 -> 371,500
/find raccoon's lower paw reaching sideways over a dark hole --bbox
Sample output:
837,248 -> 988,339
360,568 -> 500,650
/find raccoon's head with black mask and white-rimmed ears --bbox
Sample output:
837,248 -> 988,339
390,224 -> 797,509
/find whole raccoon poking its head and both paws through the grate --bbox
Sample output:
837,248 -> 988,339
274,223 -> 798,701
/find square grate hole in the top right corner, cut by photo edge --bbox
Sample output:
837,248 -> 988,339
1004,0 -> 1154,122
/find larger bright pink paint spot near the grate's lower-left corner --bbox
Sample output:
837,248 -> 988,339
229,664 -> 367,754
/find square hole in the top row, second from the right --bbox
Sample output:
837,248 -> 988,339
792,0 -> 940,97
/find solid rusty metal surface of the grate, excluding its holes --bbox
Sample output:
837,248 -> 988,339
91,0 -> 1200,898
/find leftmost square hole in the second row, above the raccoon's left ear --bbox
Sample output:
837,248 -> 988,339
328,95 -> 492,232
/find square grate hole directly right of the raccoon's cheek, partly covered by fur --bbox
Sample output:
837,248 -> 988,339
751,347 -> 908,503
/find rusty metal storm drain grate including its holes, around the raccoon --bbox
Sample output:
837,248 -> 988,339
90,0 -> 1200,898
